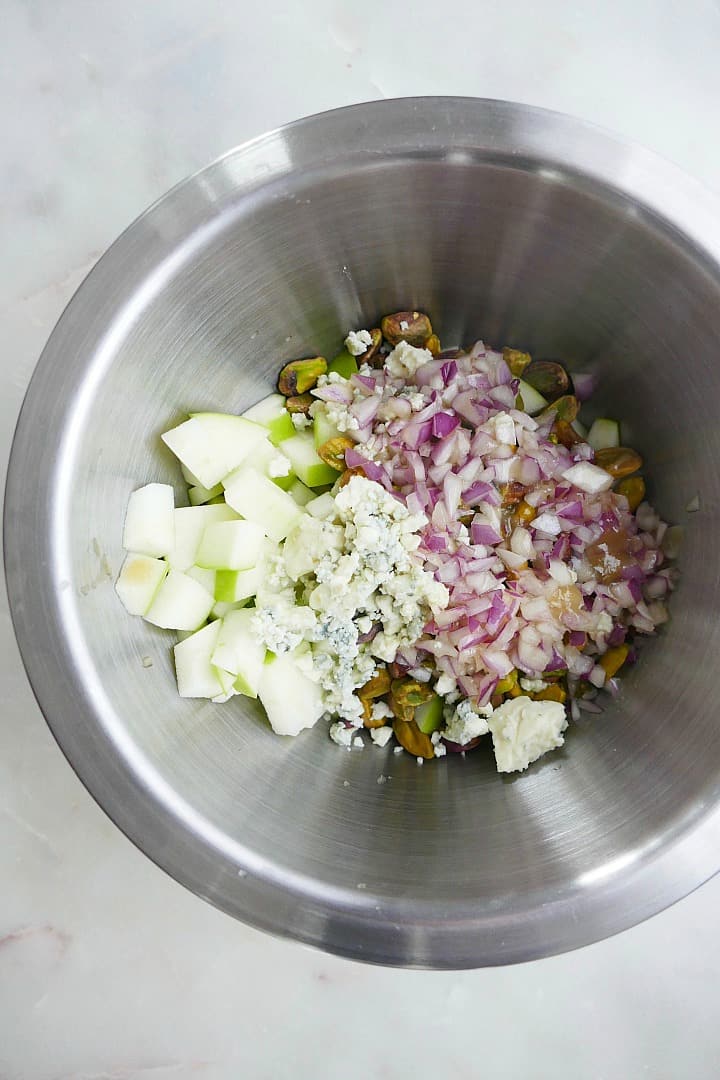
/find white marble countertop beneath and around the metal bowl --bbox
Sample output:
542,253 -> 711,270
0,0 -> 720,1080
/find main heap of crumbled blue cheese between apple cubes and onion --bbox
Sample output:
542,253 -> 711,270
253,476 -> 449,721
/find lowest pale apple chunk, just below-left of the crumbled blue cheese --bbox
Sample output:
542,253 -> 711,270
258,649 -> 325,735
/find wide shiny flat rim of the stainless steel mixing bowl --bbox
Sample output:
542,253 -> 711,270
3,97 -> 720,969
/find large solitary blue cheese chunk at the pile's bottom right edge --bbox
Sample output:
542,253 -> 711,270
489,697 -> 568,772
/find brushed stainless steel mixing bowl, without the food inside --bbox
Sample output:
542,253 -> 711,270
5,98 -> 720,968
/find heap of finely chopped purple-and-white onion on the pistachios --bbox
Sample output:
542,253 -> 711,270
334,328 -> 674,716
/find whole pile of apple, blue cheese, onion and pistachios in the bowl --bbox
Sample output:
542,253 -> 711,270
117,311 -> 678,772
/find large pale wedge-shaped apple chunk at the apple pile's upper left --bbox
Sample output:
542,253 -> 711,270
162,413 -> 267,488
